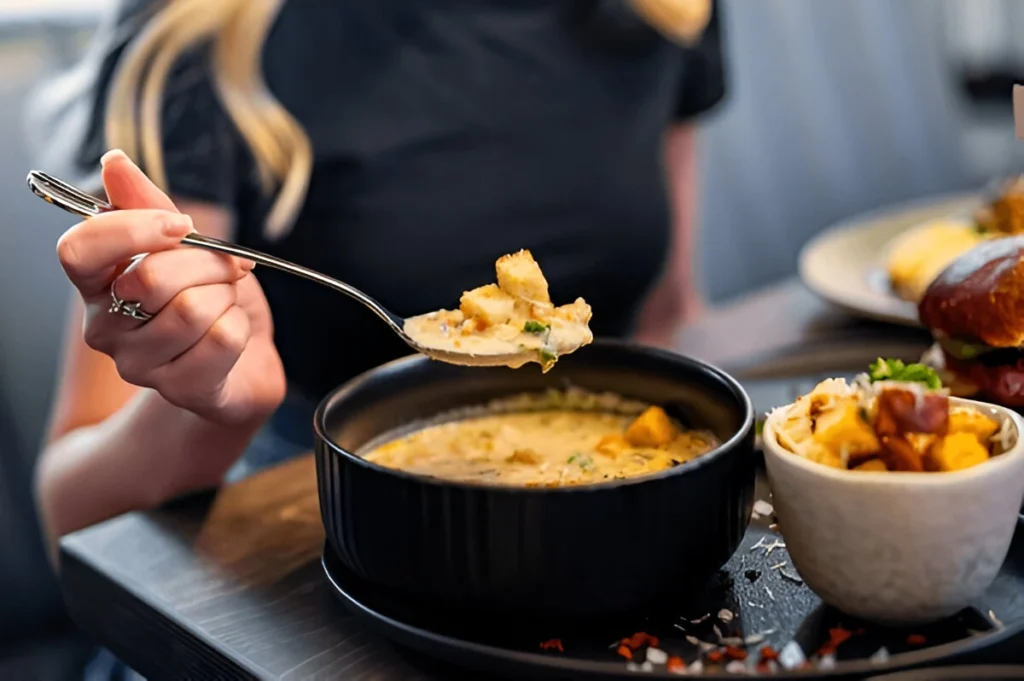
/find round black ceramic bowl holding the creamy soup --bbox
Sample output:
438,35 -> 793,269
315,341 -> 756,616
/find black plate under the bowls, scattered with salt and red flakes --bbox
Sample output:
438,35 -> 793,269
324,476 -> 1024,679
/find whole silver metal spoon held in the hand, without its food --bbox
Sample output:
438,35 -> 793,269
28,170 -> 536,367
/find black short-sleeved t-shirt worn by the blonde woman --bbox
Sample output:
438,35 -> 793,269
61,0 -> 724,398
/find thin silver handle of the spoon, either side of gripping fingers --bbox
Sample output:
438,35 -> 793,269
28,170 -> 406,338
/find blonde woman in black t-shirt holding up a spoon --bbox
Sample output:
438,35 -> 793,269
37,0 -> 723,585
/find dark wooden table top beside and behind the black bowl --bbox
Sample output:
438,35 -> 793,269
60,282 -> 942,681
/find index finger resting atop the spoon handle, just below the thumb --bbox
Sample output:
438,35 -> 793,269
57,209 -> 193,300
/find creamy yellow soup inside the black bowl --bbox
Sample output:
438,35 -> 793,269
366,407 -> 718,487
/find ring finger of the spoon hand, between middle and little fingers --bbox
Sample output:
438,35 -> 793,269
105,284 -> 238,376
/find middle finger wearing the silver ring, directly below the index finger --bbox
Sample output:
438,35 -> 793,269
113,248 -> 255,314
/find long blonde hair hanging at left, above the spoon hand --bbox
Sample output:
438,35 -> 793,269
105,0 -> 313,239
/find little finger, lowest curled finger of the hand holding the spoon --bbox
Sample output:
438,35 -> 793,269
156,305 -> 252,411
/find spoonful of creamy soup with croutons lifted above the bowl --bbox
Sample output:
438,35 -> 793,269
404,251 -> 594,371
